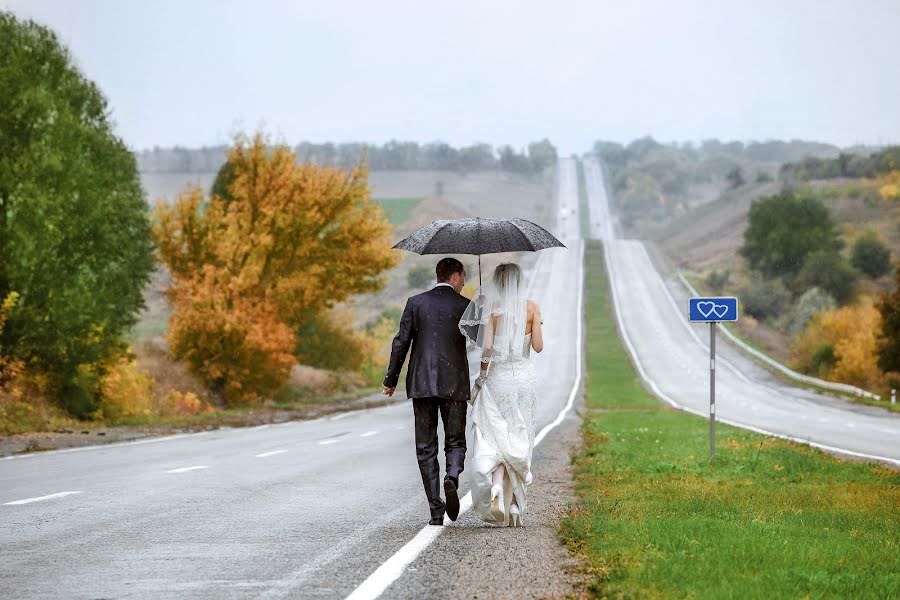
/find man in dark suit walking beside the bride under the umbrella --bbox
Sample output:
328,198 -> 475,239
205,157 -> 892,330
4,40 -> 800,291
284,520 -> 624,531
384,258 -> 469,525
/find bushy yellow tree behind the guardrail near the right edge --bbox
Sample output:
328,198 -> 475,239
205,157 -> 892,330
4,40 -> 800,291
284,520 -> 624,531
792,296 -> 883,389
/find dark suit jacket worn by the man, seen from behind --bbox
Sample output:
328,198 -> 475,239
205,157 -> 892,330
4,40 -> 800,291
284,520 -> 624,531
384,285 -> 469,400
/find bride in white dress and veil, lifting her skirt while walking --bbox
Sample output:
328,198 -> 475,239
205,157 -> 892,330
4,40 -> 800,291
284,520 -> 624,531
459,263 -> 544,527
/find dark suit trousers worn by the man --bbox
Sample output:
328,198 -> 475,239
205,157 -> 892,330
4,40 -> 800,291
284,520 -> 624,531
413,398 -> 469,517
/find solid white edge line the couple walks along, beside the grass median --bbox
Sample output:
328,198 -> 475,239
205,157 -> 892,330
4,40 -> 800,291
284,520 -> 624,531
346,242 -> 584,600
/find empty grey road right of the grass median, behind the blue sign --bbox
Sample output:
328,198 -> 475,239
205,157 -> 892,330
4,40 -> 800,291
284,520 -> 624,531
585,160 -> 900,464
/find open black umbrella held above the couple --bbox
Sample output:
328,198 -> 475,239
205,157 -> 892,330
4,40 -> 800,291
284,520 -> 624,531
394,218 -> 566,286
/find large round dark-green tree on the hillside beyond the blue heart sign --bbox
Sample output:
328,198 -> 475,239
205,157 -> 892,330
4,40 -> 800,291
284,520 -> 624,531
740,190 -> 843,278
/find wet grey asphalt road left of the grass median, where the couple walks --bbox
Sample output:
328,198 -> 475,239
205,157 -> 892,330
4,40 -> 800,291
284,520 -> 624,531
0,160 -> 582,599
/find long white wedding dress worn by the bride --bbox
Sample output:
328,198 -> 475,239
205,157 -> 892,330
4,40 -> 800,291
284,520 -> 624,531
470,334 -> 537,526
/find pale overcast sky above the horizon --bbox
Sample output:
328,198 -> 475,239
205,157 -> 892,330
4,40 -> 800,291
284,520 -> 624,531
0,0 -> 900,154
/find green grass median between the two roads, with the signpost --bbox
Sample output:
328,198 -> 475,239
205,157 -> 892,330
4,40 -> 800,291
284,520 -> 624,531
561,245 -> 900,599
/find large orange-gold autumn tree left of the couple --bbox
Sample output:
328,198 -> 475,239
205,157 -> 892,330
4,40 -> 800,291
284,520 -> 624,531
155,135 -> 397,402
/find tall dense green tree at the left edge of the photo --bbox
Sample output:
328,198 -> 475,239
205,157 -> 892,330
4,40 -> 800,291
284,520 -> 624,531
0,12 -> 154,417
